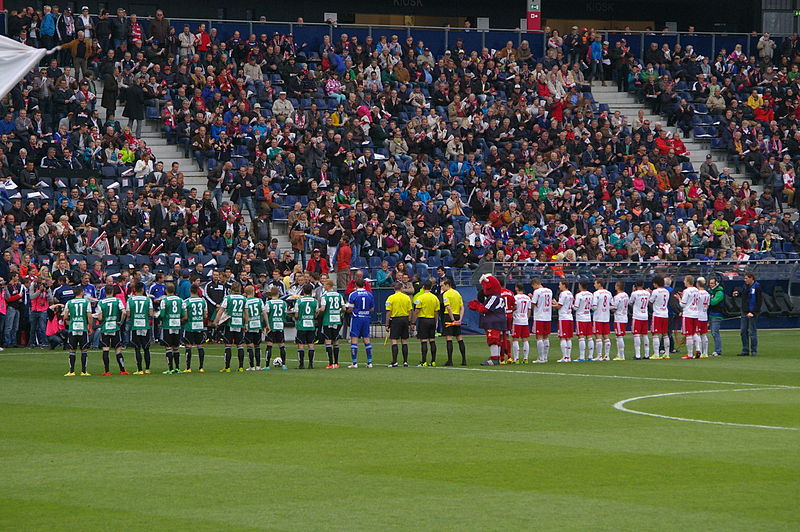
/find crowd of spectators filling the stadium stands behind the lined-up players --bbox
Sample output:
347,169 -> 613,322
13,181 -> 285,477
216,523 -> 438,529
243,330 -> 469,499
0,6 -> 800,350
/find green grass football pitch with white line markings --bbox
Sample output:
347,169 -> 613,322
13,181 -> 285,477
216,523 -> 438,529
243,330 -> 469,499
0,331 -> 800,532
